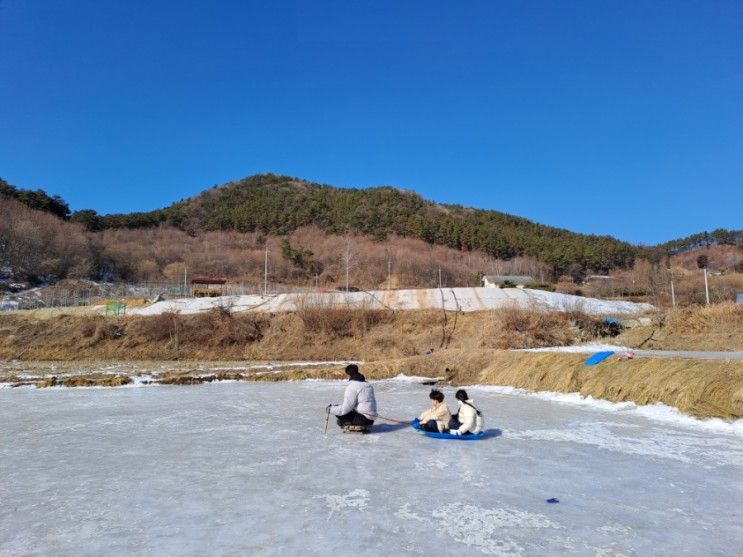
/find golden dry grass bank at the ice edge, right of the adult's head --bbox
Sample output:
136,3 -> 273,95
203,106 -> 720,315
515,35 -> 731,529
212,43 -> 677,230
364,350 -> 743,419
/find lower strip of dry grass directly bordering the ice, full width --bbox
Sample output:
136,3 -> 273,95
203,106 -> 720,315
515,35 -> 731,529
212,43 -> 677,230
0,349 -> 743,419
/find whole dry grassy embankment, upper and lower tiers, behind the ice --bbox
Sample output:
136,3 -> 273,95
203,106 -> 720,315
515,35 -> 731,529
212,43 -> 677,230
0,304 -> 743,418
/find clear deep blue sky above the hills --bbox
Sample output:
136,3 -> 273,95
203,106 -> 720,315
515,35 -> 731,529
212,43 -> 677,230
0,0 -> 743,244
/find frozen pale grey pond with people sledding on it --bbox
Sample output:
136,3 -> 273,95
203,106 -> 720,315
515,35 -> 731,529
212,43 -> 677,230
0,378 -> 743,556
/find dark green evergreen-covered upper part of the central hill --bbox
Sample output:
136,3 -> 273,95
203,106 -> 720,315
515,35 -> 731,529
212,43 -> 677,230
81,174 -> 638,273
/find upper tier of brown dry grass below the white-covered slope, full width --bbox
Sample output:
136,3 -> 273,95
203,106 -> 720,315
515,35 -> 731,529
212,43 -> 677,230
0,304 -> 743,361
